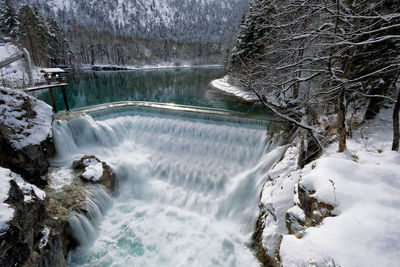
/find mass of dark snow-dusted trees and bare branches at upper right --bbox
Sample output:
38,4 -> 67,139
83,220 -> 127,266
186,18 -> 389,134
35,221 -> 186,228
230,0 -> 400,152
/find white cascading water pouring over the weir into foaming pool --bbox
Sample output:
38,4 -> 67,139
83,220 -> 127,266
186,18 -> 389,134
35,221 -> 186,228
53,108 -> 283,266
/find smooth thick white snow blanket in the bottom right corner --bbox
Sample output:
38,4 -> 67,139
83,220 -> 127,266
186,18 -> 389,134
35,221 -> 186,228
281,151 -> 400,266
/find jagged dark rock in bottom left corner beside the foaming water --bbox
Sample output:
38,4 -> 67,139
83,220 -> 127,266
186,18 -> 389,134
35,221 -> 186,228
0,169 -> 73,267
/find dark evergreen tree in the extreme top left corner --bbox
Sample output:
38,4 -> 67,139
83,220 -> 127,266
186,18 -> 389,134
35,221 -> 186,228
0,0 -> 18,38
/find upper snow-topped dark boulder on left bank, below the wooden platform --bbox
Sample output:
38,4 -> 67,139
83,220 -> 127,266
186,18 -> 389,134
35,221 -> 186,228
0,88 -> 54,185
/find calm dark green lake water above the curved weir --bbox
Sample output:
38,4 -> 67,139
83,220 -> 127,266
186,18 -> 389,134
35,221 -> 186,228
38,67 -> 265,114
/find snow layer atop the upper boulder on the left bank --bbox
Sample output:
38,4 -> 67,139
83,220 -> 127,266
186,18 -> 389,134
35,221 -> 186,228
0,88 -> 53,150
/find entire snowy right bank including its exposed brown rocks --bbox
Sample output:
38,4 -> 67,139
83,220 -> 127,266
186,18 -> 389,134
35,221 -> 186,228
261,109 -> 400,267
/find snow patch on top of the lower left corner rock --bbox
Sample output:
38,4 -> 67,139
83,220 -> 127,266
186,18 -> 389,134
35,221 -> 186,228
0,167 -> 46,231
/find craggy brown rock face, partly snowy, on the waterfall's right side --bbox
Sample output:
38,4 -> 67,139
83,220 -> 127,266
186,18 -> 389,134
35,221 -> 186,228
253,147 -> 335,267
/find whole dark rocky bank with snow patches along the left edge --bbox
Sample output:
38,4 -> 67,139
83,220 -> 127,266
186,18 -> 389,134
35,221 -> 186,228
0,89 -> 77,266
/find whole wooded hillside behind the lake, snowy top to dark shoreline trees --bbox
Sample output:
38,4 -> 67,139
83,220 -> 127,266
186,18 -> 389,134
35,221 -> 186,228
0,0 -> 248,66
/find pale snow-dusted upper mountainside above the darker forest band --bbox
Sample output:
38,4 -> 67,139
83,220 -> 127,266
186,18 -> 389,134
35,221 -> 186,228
14,0 -> 248,42
